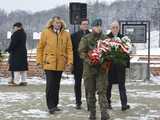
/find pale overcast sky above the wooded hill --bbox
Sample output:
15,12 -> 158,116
0,0 -> 116,12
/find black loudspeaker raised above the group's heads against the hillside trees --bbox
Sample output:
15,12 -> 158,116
69,2 -> 87,24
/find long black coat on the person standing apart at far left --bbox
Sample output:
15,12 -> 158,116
6,29 -> 28,71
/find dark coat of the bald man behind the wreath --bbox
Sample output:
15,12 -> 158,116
107,33 -> 130,84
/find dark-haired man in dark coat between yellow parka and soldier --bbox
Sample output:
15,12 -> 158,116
71,19 -> 89,109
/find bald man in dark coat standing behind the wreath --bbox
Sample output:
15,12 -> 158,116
107,21 -> 130,111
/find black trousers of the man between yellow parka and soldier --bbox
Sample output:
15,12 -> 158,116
74,71 -> 82,105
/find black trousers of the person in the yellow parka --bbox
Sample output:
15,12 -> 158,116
45,70 -> 62,110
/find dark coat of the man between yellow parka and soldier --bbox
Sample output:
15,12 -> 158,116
71,31 -> 90,73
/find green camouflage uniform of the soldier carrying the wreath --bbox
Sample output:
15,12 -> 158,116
79,33 -> 109,120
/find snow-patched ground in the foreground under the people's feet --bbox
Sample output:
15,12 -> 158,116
0,75 -> 160,120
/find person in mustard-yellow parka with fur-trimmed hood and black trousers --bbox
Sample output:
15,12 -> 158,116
37,16 -> 73,114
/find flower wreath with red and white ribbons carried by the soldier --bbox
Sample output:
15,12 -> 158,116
88,36 -> 131,65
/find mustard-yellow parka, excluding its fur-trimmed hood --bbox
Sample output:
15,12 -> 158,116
36,28 -> 73,71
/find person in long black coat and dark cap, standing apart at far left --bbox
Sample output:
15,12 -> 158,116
6,22 -> 28,85
